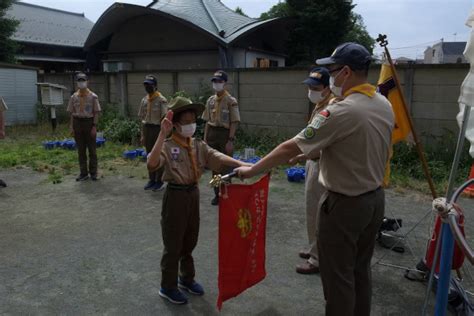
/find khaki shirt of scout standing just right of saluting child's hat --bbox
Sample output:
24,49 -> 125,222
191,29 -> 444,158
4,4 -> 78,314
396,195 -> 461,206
202,93 -> 240,128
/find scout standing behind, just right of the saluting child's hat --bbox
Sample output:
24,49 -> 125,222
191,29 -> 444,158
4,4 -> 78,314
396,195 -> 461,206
202,70 -> 240,205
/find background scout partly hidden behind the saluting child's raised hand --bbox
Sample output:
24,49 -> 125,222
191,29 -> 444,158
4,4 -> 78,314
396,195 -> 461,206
138,75 -> 168,191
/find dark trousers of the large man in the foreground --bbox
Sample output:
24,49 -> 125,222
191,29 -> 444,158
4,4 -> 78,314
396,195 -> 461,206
318,188 -> 385,316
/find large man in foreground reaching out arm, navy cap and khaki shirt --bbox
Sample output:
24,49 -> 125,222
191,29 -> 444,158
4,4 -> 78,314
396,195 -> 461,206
236,43 -> 394,316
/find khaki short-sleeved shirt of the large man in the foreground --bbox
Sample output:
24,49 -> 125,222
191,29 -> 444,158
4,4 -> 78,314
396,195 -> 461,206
294,93 -> 394,196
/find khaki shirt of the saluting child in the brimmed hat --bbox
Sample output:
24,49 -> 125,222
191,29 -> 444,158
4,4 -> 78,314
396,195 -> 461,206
157,138 -> 225,185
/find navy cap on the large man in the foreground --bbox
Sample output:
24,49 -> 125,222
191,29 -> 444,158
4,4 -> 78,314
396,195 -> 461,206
316,42 -> 372,70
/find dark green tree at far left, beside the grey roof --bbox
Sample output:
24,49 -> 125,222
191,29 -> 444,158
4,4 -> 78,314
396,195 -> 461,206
0,0 -> 20,63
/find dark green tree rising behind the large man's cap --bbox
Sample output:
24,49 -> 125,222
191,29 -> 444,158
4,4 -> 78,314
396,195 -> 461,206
260,0 -> 375,65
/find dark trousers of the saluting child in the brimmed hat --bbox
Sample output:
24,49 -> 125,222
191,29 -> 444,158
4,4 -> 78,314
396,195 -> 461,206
161,184 -> 200,289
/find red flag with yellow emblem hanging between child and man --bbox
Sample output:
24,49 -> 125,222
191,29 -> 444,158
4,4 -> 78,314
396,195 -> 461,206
217,174 -> 270,310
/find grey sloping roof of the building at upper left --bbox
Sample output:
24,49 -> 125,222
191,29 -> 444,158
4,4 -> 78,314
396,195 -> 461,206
7,2 -> 94,47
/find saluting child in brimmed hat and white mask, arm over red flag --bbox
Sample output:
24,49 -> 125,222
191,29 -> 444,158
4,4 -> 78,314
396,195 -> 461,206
148,97 -> 248,304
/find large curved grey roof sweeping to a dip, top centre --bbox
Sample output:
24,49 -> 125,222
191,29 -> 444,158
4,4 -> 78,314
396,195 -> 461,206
84,0 -> 280,49
